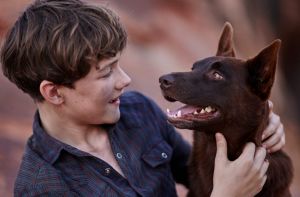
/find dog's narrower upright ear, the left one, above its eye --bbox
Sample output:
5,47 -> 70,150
216,22 -> 235,57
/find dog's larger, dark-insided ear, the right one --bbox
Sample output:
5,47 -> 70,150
247,39 -> 281,100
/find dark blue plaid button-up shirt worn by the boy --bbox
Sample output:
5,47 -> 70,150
14,92 -> 191,197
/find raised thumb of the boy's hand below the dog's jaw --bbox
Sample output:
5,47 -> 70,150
215,133 -> 228,165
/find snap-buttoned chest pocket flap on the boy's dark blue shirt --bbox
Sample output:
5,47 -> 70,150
142,140 -> 173,168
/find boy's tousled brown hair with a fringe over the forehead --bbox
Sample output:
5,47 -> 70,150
1,0 -> 127,101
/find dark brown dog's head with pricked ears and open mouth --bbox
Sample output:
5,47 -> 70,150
159,23 -> 281,132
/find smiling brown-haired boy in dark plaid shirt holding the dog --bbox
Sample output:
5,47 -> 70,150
1,0 -> 284,196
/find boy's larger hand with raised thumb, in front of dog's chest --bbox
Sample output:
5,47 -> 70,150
211,133 -> 269,197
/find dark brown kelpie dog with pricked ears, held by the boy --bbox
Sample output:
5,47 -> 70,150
159,23 -> 293,197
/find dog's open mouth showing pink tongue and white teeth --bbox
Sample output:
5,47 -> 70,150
167,105 -> 220,123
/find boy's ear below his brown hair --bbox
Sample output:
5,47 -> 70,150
40,80 -> 64,105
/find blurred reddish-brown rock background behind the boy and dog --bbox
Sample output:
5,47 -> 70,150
0,0 -> 300,197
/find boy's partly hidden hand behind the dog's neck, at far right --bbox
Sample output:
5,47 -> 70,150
262,101 -> 285,153
